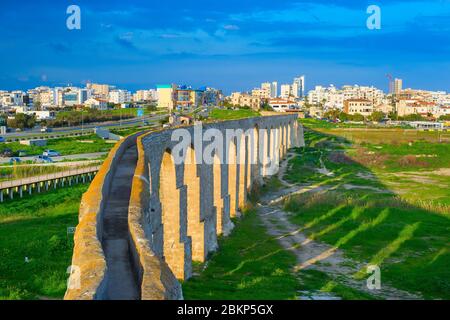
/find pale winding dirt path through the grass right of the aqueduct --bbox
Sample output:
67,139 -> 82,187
257,154 -> 420,300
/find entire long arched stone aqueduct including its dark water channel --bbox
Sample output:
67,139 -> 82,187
65,114 -> 303,300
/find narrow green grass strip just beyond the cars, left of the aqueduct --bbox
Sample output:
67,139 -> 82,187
0,135 -> 114,156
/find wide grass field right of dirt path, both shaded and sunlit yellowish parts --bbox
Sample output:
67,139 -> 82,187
286,125 -> 450,299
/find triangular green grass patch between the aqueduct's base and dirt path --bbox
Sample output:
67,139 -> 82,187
183,210 -> 298,300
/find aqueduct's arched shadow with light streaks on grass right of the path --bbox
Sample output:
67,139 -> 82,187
285,130 -> 450,299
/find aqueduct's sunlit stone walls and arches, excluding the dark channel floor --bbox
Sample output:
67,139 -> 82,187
65,114 -> 303,299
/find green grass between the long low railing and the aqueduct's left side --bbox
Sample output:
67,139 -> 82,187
0,185 -> 88,299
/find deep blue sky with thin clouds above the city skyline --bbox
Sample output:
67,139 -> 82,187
0,0 -> 450,92
